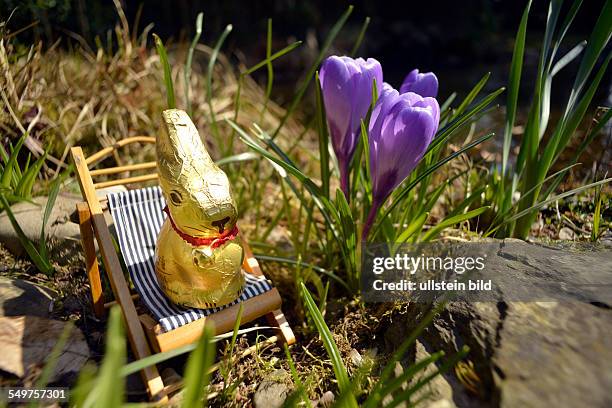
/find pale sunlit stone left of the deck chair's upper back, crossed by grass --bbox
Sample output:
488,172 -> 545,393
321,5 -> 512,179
0,195 -> 83,256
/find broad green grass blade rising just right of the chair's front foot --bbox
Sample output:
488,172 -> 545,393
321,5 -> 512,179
300,282 -> 357,407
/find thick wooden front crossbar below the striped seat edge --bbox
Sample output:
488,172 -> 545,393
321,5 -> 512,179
148,288 -> 281,352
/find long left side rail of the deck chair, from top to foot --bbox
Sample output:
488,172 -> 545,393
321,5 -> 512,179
71,147 -> 166,400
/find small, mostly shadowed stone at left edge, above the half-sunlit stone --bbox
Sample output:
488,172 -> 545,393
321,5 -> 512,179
0,276 -> 56,317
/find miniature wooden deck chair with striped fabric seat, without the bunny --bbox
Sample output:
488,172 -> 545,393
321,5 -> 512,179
71,136 -> 295,400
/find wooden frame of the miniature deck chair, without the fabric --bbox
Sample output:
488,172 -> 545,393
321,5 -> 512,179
71,136 -> 295,401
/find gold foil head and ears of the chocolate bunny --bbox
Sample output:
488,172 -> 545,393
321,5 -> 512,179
157,109 -> 238,238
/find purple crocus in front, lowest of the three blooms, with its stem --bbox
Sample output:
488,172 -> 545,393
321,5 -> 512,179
362,83 -> 440,240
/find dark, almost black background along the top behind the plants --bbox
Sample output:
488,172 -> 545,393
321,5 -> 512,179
0,0 -> 610,104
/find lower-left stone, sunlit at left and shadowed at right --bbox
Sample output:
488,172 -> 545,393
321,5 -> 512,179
0,316 -> 89,383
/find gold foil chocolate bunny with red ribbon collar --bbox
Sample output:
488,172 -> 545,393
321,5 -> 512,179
155,109 -> 245,308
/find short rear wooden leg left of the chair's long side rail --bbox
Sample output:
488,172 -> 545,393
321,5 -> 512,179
76,203 -> 104,318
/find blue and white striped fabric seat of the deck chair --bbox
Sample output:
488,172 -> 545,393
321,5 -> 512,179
108,187 -> 272,332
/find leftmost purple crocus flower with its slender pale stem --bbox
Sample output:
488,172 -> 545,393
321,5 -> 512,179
319,56 -> 382,198
